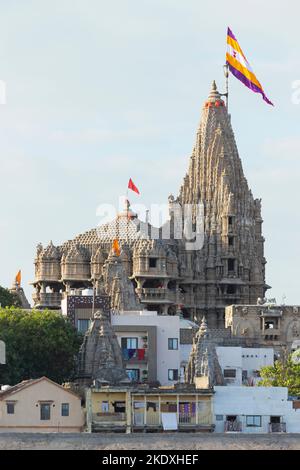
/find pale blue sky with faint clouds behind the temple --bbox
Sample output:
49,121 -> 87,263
0,0 -> 300,304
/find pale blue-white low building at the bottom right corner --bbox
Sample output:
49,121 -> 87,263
213,386 -> 300,433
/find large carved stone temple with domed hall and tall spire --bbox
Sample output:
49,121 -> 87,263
33,82 -> 269,328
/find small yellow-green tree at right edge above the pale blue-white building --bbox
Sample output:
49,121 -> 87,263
259,356 -> 300,395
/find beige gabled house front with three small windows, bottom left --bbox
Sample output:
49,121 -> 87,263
0,379 -> 84,432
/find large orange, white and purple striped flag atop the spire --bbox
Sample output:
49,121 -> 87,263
226,28 -> 274,106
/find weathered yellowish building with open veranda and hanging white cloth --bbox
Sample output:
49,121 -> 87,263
86,387 -> 213,433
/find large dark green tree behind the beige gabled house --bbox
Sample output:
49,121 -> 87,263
0,308 -> 82,385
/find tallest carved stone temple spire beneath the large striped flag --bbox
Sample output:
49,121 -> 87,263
177,82 -> 269,328
